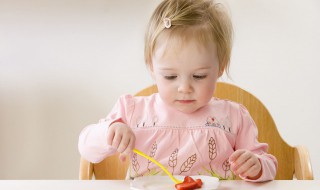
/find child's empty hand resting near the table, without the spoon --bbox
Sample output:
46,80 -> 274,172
229,150 -> 262,180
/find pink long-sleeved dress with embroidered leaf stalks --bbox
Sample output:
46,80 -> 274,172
79,94 -> 277,181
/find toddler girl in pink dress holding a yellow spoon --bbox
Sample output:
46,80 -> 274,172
79,0 -> 277,181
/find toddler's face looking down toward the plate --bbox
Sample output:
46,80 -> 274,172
151,37 -> 220,113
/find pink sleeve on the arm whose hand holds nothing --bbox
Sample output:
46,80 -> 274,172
235,106 -> 278,182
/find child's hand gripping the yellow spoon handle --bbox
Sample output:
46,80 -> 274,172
107,122 -> 136,161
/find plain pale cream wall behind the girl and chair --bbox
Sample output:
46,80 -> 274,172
0,0 -> 320,179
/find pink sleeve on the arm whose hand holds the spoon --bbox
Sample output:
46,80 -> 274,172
78,95 -> 133,163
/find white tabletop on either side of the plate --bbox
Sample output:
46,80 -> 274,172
0,180 -> 320,190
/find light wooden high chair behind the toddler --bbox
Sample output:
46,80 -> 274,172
79,82 -> 313,180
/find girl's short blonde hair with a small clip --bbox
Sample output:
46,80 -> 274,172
144,0 -> 233,74
